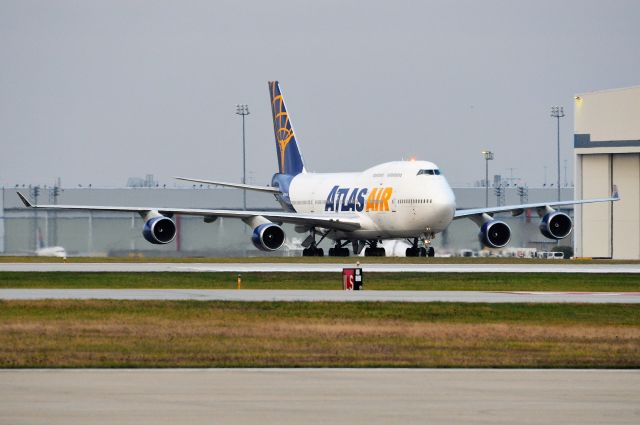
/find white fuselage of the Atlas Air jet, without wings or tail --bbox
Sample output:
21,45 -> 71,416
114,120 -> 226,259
289,161 -> 455,239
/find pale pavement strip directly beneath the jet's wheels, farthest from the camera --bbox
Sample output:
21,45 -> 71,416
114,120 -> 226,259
0,261 -> 640,274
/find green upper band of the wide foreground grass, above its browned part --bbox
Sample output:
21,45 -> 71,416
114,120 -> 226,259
0,300 -> 640,324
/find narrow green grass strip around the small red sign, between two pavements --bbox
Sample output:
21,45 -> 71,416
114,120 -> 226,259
0,269 -> 640,292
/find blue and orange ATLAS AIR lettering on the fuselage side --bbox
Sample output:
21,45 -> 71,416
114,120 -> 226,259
324,186 -> 393,212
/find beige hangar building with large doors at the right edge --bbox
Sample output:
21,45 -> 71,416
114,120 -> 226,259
574,86 -> 640,259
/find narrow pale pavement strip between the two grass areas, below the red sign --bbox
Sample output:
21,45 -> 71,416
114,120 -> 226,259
0,289 -> 640,304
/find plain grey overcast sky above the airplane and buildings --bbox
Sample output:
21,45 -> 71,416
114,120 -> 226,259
0,0 -> 640,186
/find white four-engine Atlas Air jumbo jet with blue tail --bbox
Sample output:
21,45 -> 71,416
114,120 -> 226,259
18,81 -> 619,257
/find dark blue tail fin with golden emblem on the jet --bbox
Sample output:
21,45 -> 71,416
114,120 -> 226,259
269,81 -> 306,176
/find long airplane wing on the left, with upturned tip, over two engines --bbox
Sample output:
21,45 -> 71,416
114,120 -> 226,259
18,192 -> 360,231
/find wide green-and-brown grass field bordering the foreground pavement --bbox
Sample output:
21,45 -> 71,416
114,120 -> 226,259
0,301 -> 640,368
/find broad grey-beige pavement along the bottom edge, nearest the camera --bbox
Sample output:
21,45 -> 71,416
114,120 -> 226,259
0,369 -> 640,425
